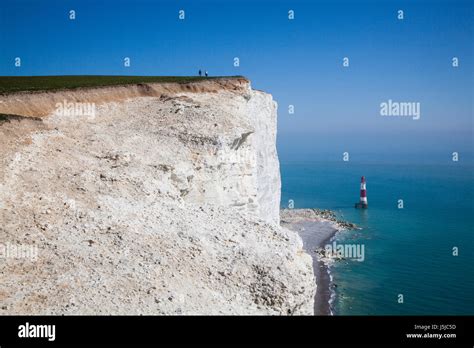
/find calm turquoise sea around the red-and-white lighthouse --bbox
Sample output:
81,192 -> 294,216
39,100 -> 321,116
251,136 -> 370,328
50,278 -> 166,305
281,161 -> 474,315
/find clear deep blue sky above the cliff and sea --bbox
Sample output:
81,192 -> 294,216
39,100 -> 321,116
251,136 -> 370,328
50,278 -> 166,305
0,0 -> 474,159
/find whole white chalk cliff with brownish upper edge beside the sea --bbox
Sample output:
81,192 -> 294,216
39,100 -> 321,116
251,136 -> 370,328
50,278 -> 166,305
0,79 -> 315,314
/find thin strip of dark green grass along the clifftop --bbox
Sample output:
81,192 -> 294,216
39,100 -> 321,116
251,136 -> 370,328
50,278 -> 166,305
0,75 -> 242,94
